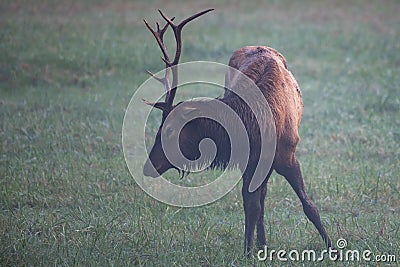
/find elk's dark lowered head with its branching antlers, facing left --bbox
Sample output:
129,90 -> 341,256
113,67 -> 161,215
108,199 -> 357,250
143,9 -> 213,177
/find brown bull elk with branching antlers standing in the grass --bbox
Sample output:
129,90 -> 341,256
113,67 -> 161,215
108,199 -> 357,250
143,9 -> 332,253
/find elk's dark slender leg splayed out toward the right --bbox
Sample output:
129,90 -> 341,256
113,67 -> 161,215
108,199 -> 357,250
277,154 -> 332,247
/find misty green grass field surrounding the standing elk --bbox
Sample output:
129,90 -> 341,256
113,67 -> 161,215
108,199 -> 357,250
0,0 -> 400,266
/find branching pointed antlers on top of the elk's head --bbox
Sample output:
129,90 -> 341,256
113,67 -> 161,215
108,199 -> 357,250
143,9 -> 214,118
